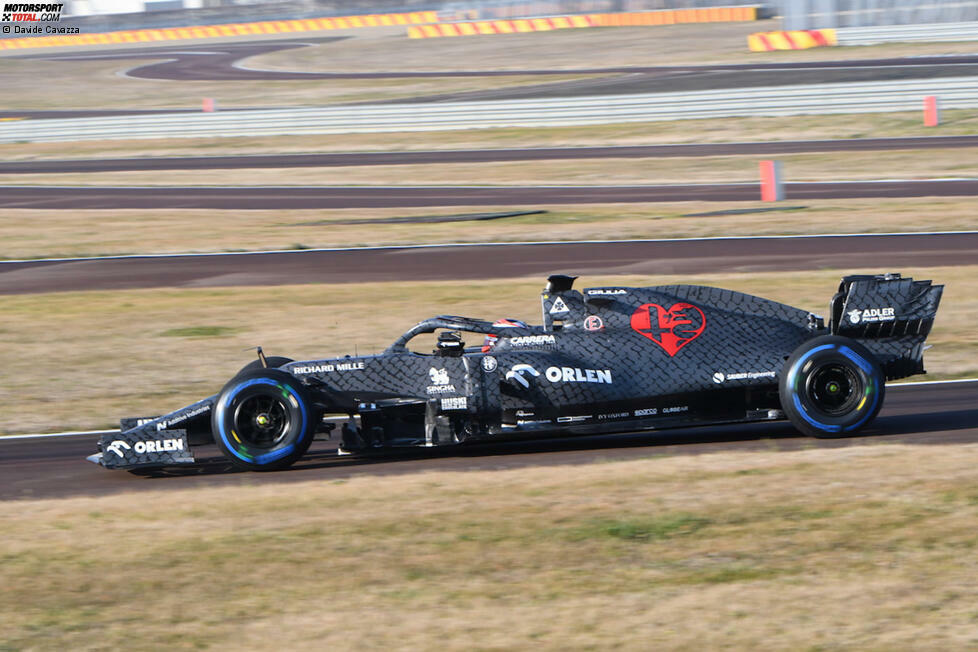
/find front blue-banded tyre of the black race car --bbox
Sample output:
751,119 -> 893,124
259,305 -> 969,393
211,369 -> 320,471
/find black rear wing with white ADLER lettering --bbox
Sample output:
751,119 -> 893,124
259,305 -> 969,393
829,274 -> 944,380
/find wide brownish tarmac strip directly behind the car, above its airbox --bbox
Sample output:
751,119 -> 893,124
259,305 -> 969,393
0,232 -> 978,295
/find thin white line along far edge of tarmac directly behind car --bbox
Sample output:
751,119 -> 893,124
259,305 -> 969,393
0,231 -> 978,266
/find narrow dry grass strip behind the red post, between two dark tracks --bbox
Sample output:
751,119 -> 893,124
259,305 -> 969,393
0,148 -> 978,186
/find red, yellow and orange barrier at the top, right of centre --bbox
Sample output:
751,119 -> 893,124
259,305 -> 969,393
408,6 -> 759,38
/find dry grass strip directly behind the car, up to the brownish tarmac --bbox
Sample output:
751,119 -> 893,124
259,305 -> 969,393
0,266 -> 978,434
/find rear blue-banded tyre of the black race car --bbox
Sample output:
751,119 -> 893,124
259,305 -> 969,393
779,335 -> 886,437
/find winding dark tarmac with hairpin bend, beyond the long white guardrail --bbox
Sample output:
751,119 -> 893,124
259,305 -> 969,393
9,37 -> 978,118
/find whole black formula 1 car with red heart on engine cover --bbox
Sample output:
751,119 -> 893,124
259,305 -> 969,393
89,274 -> 943,471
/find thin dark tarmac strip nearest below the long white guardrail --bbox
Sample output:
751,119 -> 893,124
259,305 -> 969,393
0,136 -> 978,174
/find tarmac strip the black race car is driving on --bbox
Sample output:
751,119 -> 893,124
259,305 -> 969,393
0,382 -> 978,500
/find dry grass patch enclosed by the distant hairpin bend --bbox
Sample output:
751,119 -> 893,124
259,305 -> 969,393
249,20 -> 975,72
